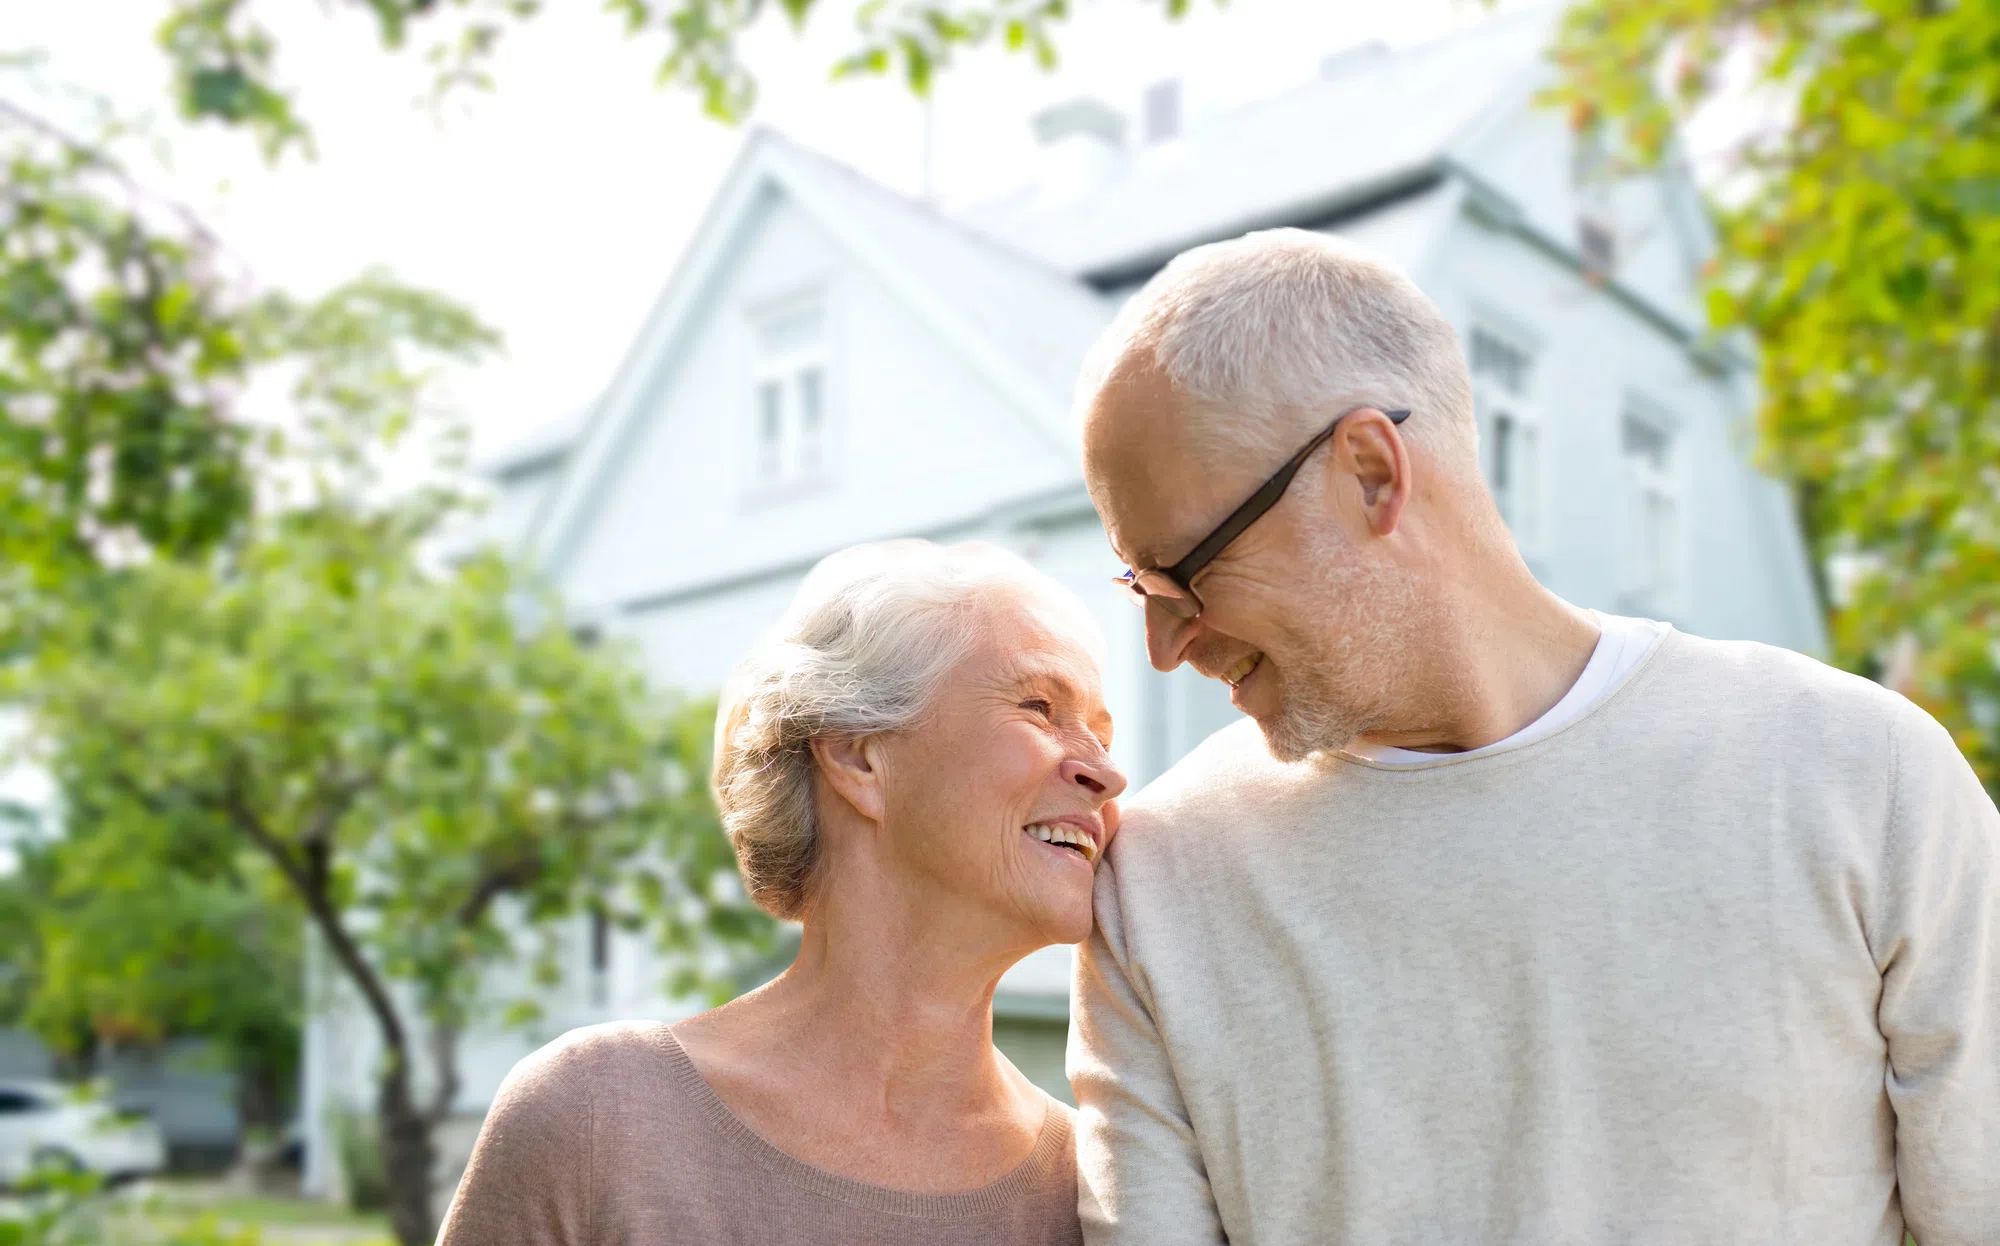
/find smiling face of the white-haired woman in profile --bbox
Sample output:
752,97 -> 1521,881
880,588 -> 1126,950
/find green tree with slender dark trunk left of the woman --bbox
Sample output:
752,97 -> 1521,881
6,258 -> 770,1244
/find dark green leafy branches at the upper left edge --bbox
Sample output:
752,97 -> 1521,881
0,75 -> 250,576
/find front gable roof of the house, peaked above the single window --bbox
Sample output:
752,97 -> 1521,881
524,128 -> 1114,566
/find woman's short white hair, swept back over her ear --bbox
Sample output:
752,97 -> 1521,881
712,540 -> 1102,920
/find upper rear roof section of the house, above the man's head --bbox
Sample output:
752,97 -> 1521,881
964,8 -> 1556,284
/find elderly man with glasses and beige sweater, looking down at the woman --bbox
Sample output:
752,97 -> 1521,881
1070,230 -> 2000,1246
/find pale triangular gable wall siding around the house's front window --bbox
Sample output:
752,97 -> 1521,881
558,200 -> 1074,610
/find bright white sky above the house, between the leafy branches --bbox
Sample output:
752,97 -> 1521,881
0,0 -> 1484,464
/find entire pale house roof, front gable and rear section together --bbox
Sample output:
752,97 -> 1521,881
508,8 -> 1600,564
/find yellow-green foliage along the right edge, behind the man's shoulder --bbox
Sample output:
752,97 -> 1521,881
1556,0 -> 2000,790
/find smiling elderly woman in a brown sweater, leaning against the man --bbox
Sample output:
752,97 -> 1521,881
442,542 -> 1126,1246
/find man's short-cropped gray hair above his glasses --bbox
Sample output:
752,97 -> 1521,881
1078,230 -> 1478,472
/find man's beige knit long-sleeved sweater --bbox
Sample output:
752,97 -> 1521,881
1070,634 -> 2000,1246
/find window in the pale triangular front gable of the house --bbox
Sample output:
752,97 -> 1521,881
750,300 -> 828,488
